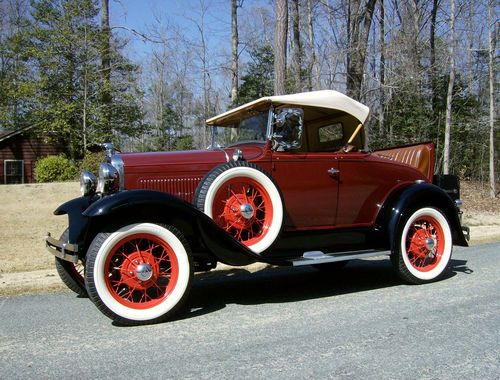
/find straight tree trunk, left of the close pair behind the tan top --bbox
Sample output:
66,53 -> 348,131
274,0 -> 288,95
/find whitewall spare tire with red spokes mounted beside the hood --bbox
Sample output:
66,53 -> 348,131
194,161 -> 283,253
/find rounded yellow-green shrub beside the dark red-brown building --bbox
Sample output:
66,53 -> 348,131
35,154 -> 78,182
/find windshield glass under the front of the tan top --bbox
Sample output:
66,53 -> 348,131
212,112 -> 268,147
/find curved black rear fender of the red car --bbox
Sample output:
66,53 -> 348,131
375,182 -> 468,251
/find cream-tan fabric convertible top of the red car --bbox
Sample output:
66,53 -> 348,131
207,90 -> 370,125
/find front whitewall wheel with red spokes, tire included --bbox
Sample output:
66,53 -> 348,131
85,223 -> 193,325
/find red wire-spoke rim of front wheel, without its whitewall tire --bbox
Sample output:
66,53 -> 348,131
104,234 -> 179,309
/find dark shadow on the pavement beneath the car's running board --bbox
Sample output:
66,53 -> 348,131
180,259 -> 398,319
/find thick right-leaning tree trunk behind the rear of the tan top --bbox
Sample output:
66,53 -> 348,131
347,0 -> 376,100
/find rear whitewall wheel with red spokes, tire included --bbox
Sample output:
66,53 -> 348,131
392,207 -> 453,284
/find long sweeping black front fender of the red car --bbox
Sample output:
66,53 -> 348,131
75,190 -> 262,266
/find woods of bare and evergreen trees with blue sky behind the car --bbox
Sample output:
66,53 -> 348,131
0,0 -> 500,197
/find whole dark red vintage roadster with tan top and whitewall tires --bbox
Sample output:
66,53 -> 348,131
46,91 -> 467,324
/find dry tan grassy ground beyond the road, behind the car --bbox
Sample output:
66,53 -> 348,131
0,182 -> 500,296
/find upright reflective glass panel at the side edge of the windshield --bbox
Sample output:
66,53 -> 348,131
272,108 -> 304,151
